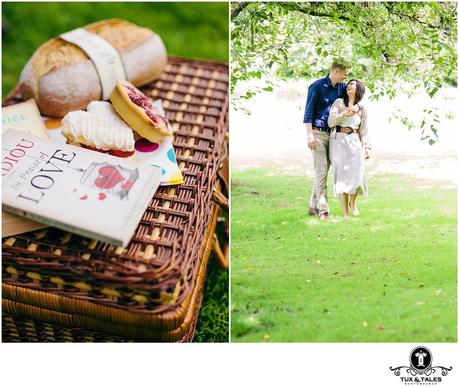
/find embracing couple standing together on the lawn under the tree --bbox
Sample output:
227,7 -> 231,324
303,59 -> 370,220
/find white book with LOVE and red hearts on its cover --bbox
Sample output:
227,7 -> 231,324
2,130 -> 161,246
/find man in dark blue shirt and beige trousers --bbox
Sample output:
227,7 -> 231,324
303,59 -> 353,220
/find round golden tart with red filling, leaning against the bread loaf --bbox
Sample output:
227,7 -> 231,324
110,81 -> 172,143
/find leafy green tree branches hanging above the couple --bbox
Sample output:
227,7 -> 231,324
231,2 -> 457,144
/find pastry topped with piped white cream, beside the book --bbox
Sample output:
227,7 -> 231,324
62,101 -> 135,157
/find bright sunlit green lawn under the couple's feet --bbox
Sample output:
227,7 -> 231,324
231,170 -> 457,342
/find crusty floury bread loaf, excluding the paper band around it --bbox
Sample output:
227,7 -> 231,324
20,19 -> 167,117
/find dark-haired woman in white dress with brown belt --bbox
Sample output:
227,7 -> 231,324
328,79 -> 370,218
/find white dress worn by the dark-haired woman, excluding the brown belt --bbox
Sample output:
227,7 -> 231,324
330,114 -> 367,195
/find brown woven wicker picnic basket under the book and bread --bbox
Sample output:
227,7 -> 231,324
2,58 -> 228,342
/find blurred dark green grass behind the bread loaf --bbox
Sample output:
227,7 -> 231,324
2,2 -> 228,99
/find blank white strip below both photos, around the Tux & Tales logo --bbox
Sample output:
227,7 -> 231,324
0,0 -> 459,387
